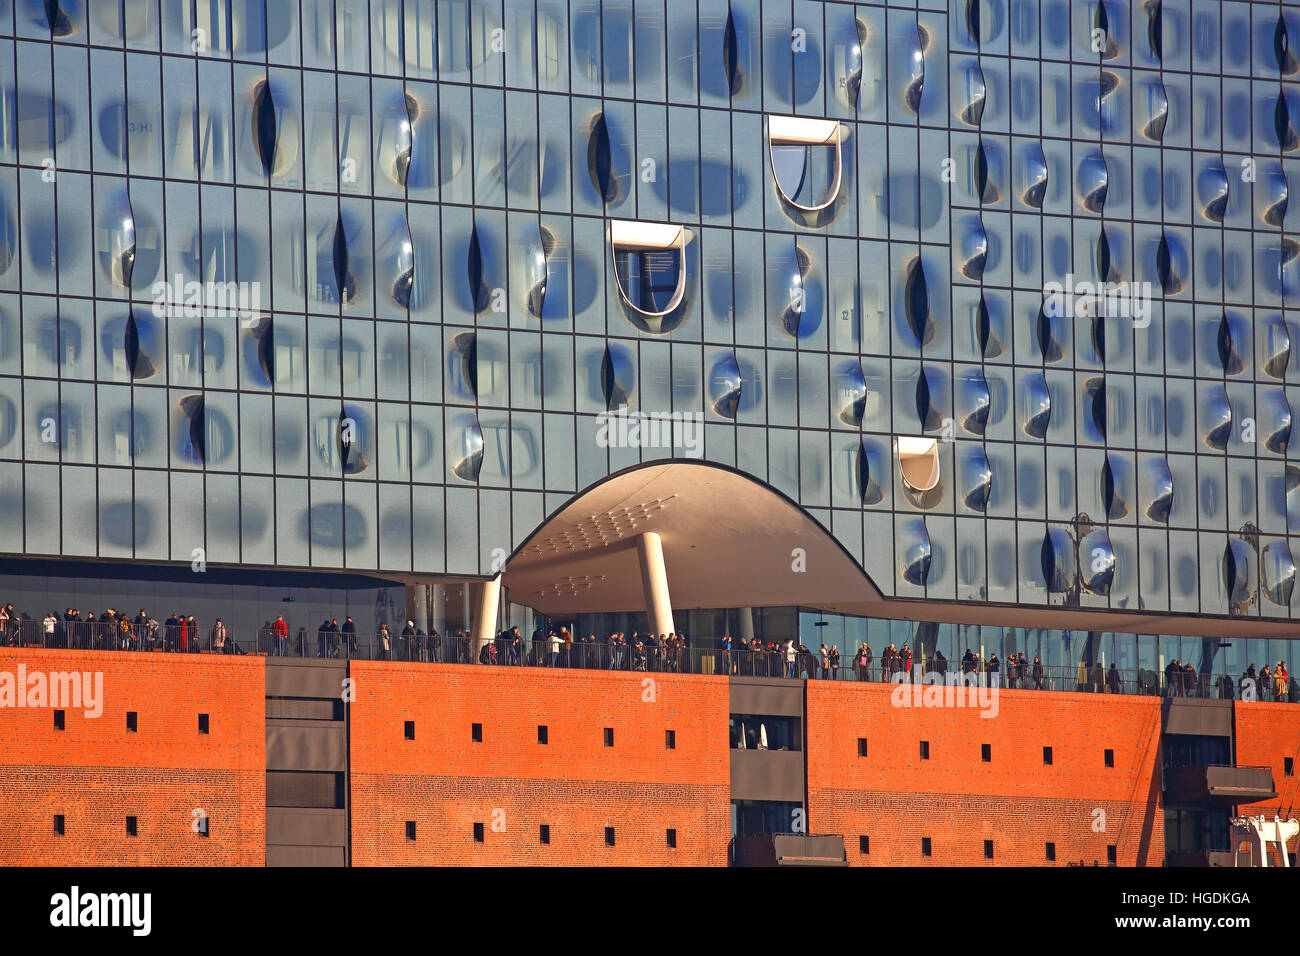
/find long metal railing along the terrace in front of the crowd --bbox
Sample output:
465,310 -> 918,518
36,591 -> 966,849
0,620 -> 1300,701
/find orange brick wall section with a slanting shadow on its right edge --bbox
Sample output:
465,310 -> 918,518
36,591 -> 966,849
807,680 -> 1165,866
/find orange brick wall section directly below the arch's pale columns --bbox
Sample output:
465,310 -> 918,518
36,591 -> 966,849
351,662 -> 731,865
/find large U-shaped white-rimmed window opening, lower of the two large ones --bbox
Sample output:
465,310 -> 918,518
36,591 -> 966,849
610,220 -> 690,334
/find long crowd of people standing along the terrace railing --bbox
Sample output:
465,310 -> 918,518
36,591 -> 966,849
0,604 -> 1291,702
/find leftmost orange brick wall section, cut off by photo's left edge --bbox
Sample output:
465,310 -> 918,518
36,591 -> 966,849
0,648 -> 267,866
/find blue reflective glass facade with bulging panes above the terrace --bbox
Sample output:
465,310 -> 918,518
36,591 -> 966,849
0,0 -> 1300,632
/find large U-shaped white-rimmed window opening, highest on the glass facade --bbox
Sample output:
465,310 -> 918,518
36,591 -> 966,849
767,116 -> 852,226
